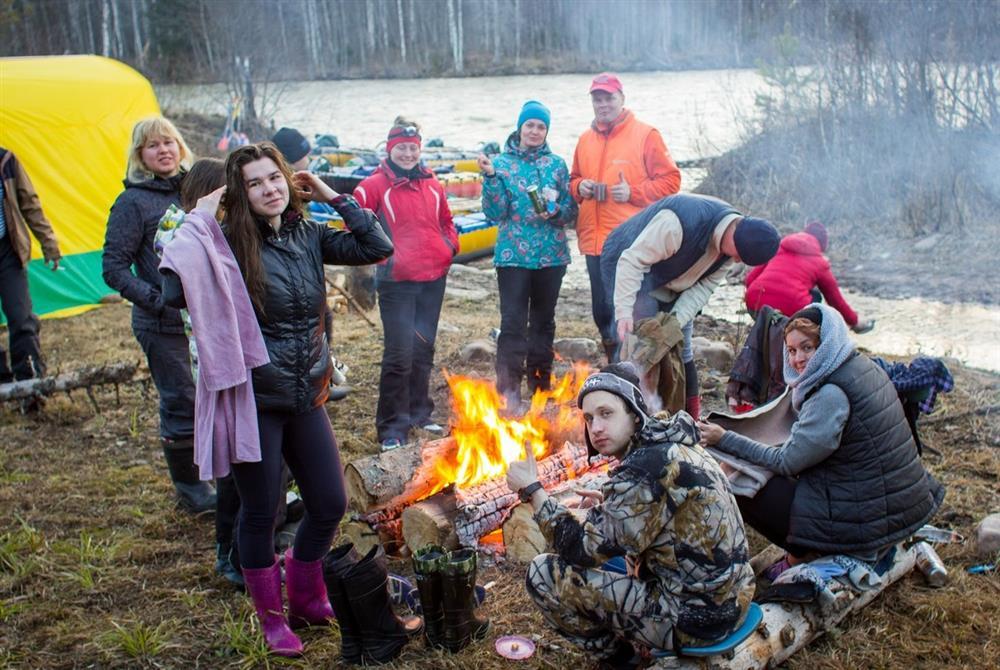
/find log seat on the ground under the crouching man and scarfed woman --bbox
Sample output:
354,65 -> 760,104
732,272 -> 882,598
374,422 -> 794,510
654,545 -> 914,670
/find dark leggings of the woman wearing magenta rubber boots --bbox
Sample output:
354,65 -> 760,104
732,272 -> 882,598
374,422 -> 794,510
232,407 -> 347,569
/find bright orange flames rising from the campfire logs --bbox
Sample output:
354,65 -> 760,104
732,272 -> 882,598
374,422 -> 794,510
436,363 -> 590,487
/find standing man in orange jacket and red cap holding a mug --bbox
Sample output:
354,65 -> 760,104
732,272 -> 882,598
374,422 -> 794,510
570,72 -> 681,361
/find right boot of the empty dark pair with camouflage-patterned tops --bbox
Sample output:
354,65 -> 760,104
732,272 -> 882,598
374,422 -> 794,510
441,549 -> 490,653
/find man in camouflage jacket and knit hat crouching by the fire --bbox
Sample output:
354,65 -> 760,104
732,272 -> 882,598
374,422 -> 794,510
507,363 -> 754,668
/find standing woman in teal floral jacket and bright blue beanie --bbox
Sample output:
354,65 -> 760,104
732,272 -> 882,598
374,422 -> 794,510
479,100 -> 577,411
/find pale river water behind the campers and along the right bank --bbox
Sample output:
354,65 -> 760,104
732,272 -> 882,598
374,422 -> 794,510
157,70 -> 1000,372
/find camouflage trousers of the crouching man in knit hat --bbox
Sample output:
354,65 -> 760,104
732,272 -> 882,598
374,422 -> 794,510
526,554 -> 677,657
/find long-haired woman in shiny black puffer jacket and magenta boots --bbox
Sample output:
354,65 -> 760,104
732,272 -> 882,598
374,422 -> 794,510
164,142 -> 393,656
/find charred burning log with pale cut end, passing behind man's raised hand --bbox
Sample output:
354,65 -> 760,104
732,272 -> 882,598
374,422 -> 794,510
402,442 -> 591,549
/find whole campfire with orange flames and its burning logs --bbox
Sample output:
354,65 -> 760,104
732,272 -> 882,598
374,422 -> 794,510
347,363 -> 606,553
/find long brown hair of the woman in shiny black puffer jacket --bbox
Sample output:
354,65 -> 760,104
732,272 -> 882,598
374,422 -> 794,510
224,142 -> 302,315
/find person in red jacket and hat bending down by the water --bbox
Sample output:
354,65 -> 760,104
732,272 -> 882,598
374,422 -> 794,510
744,221 -> 875,333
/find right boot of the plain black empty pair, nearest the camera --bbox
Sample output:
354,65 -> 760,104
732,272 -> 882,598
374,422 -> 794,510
338,544 -> 424,663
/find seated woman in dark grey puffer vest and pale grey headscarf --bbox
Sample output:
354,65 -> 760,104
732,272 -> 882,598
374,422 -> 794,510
701,304 -> 944,563
